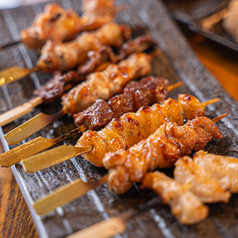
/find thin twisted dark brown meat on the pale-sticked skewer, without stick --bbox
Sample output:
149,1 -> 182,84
34,36 -> 154,103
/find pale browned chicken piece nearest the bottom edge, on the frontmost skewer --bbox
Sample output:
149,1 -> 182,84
141,171 -> 209,225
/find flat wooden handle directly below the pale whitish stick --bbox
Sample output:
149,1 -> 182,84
4,108 -> 67,145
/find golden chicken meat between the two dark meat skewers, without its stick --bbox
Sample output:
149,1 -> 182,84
62,53 -> 151,115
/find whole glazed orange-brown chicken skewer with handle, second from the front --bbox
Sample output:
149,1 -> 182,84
33,114 -> 227,215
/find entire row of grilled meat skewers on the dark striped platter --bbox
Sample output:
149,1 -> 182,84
0,0 -> 238,238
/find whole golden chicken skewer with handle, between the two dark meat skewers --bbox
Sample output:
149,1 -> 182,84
5,53 -> 152,144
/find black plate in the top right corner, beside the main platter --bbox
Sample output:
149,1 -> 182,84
164,0 -> 238,52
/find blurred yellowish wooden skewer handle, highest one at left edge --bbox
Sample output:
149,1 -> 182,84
0,66 -> 40,87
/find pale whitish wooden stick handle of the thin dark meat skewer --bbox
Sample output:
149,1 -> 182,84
0,97 -> 42,126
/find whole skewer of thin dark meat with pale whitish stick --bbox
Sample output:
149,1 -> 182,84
0,36 -> 156,126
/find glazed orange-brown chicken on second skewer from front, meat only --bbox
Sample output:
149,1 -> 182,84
102,117 -> 222,194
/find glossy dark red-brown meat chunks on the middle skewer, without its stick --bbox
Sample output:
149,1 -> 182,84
74,76 -> 168,130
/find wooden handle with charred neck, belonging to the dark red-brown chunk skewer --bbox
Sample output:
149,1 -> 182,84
0,125 -> 88,167
